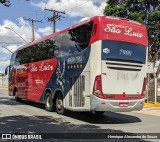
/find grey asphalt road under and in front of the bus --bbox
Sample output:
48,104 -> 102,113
0,90 -> 160,142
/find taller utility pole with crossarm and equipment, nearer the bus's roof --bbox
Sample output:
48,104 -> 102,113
44,8 -> 65,33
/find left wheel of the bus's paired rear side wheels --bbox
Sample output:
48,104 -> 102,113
45,92 -> 54,111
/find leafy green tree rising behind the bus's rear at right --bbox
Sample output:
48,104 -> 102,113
104,0 -> 160,61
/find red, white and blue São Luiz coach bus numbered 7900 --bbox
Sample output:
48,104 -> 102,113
6,16 -> 148,114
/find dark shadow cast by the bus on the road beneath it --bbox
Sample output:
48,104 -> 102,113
14,101 -> 141,124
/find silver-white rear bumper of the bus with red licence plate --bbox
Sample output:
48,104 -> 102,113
90,95 -> 144,112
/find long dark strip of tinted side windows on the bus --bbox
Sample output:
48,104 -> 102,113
15,22 -> 93,65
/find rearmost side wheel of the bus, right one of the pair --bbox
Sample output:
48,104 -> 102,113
56,94 -> 65,114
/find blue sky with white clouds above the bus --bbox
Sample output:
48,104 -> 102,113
0,0 -> 107,73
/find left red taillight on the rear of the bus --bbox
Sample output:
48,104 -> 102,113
93,75 -> 105,98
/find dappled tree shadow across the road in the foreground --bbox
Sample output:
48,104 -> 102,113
0,115 -> 150,142
